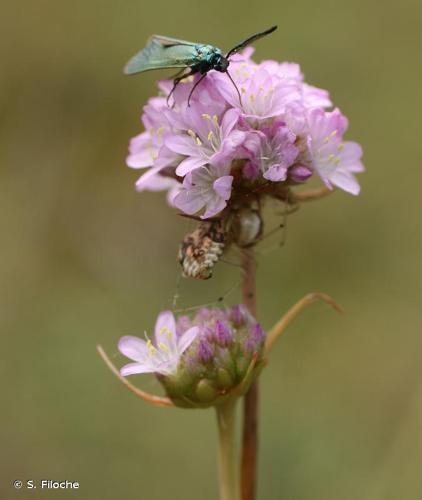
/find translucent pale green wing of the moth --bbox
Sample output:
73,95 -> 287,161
124,35 -> 196,75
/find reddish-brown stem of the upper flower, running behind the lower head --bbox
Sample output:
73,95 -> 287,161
241,247 -> 258,500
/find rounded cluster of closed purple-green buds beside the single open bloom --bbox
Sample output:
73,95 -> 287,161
158,305 -> 265,408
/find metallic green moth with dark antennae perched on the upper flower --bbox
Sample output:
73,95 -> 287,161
124,26 -> 277,105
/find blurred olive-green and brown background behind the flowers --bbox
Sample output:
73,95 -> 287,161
0,0 -> 422,500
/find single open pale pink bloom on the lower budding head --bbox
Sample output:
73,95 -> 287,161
118,311 -> 199,377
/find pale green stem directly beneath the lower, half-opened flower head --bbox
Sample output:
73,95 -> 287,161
216,399 -> 239,500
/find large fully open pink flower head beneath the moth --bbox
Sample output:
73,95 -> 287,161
127,48 -> 364,219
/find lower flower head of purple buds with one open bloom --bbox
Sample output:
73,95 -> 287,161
118,305 -> 265,407
